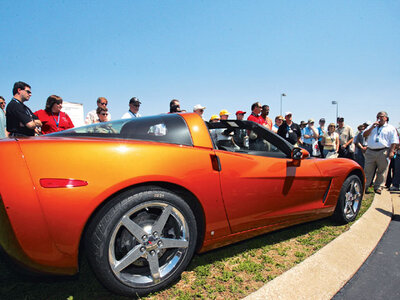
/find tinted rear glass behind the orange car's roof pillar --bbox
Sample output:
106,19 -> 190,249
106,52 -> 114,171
47,114 -> 193,146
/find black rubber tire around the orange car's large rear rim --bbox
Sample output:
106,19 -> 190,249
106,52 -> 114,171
85,188 -> 197,296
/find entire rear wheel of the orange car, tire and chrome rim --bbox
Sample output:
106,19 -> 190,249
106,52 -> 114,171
85,187 -> 197,296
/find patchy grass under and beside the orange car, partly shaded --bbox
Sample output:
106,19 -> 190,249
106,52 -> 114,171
0,194 -> 373,300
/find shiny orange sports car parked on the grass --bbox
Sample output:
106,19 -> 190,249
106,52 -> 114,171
0,114 -> 364,295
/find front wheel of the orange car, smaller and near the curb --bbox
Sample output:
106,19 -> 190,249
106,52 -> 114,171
333,175 -> 364,224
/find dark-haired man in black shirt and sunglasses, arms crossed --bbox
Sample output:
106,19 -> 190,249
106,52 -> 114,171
6,81 -> 42,137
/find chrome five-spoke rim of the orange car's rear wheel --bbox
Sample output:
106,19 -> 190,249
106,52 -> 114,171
108,201 -> 189,287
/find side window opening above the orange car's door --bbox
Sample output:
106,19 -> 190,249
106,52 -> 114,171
207,120 -> 292,158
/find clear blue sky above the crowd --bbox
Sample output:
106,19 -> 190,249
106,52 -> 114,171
0,0 -> 400,127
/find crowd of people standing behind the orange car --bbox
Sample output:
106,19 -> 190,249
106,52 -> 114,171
0,81 -> 400,193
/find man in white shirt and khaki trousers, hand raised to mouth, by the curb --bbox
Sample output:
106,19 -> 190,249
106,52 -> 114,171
363,111 -> 399,194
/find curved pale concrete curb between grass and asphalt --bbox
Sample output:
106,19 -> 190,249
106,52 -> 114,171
244,190 -> 393,300
